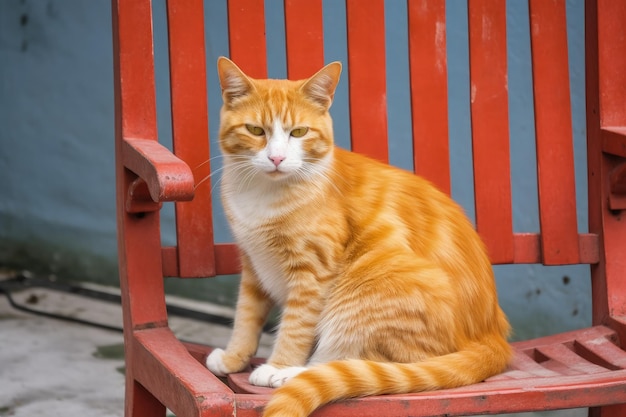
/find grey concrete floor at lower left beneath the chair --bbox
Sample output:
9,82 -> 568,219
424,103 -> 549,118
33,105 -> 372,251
0,276 -> 271,417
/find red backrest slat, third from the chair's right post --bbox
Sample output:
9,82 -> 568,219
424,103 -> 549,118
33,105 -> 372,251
408,1 -> 450,194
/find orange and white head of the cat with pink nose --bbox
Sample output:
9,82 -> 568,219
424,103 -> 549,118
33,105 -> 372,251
217,57 -> 341,180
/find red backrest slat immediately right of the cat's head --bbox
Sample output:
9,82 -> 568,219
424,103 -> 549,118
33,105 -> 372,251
346,0 -> 389,162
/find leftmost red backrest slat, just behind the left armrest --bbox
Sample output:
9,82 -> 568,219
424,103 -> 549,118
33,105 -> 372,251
167,0 -> 215,277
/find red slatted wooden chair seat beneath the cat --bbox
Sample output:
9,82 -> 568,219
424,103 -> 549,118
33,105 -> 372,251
213,326 -> 626,415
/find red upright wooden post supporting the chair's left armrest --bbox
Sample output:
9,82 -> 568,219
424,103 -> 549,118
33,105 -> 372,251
112,1 -> 168,331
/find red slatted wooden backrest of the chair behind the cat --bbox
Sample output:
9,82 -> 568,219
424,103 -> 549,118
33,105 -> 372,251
112,0 -> 626,324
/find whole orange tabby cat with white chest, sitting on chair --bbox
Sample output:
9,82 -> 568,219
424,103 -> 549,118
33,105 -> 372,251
207,58 -> 511,417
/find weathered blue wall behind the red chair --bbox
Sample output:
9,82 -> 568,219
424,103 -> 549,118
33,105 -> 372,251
0,0 -> 590,337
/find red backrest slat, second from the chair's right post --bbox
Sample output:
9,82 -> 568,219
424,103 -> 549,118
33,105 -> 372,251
469,0 -> 515,263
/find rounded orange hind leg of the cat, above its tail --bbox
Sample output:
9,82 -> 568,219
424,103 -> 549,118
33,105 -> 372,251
309,249 -> 458,365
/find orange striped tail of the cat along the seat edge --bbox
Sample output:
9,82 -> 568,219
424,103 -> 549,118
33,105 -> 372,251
263,336 -> 511,417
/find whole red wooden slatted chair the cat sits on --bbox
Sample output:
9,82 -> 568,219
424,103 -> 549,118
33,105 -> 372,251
113,0 -> 626,417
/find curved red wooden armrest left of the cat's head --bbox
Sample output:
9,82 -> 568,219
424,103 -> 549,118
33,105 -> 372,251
122,139 -> 194,203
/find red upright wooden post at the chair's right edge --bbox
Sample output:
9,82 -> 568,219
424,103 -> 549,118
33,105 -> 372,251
585,1 -> 626,332
